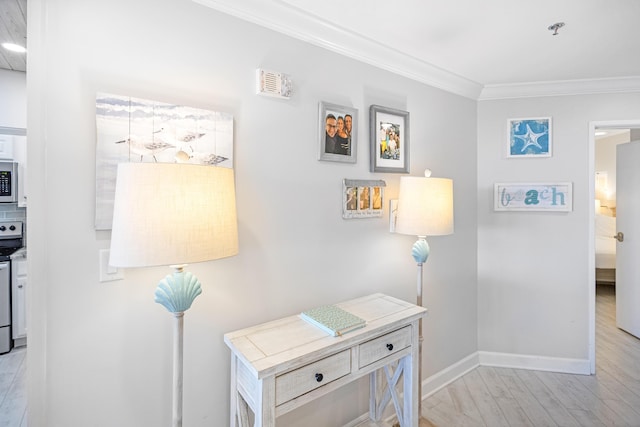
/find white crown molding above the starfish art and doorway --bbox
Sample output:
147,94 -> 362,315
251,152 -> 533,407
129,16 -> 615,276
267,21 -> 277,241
478,76 -> 640,101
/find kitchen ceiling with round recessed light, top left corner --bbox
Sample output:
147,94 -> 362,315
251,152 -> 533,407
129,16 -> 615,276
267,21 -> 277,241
0,0 -> 27,72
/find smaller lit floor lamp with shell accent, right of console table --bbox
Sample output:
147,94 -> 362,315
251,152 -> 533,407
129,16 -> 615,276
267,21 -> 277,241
396,169 -> 453,425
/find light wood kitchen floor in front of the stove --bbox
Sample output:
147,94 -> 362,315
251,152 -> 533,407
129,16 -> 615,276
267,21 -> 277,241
0,347 -> 27,427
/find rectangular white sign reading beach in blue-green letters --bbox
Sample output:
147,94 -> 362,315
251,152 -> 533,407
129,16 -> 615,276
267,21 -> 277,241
493,182 -> 573,212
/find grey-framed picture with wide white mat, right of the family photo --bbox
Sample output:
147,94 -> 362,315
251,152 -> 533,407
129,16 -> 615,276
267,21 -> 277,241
369,105 -> 409,173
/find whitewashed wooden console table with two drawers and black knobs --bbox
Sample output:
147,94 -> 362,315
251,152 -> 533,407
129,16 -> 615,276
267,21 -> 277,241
224,294 -> 426,427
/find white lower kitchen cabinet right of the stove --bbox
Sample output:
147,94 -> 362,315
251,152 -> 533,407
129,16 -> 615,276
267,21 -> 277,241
11,249 -> 27,347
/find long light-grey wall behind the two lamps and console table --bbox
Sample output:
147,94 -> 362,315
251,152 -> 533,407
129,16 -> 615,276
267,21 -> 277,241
28,0 -> 477,427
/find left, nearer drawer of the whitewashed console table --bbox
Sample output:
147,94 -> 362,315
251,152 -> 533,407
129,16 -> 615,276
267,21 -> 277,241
276,349 -> 351,406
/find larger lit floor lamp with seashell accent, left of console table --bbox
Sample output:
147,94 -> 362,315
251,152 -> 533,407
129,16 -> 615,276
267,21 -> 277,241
109,163 -> 238,427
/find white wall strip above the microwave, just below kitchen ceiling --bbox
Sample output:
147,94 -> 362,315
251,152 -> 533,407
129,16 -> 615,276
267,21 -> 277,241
0,70 -> 27,129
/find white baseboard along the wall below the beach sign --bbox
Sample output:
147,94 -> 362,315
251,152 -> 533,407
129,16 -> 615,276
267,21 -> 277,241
478,351 -> 590,375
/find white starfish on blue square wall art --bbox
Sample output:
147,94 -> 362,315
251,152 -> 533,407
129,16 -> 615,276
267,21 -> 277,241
507,117 -> 551,158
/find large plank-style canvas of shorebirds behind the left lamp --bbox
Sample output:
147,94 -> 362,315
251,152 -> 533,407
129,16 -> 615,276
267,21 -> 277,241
95,93 -> 233,230
